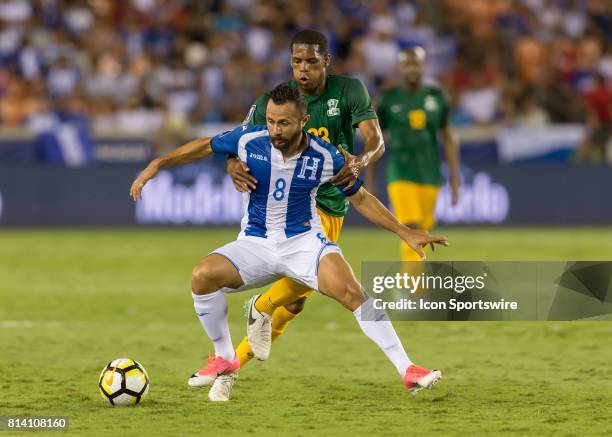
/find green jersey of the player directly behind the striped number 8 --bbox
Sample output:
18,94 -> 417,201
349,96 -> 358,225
245,75 -> 376,216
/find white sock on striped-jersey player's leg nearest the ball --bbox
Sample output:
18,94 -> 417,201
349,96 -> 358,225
191,291 -> 236,360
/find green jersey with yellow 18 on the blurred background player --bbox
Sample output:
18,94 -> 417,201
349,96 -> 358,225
377,86 -> 448,185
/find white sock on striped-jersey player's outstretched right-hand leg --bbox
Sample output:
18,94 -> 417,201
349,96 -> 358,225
353,298 -> 412,377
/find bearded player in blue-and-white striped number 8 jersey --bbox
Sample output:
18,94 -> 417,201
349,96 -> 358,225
130,85 -> 447,401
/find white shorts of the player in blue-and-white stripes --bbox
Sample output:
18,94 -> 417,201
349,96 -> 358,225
211,231 -> 342,292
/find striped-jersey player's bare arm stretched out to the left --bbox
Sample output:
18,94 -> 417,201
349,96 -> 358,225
130,137 -> 213,201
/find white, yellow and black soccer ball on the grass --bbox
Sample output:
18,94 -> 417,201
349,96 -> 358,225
98,358 -> 149,405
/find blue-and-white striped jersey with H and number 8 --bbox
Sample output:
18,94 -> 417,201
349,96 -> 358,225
211,125 -> 362,241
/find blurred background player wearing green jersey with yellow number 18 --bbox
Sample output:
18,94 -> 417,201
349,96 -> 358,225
369,47 -> 459,261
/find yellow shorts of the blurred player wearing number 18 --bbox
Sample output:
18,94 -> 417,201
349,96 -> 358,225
387,181 -> 440,230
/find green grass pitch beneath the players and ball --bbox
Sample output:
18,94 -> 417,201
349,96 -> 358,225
0,228 -> 612,436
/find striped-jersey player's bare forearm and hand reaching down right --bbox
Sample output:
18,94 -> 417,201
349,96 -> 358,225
348,187 -> 448,259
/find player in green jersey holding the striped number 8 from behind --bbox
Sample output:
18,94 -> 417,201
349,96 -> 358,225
228,30 -> 384,365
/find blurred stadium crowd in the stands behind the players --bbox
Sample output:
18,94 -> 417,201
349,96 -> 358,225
0,0 -> 612,148
